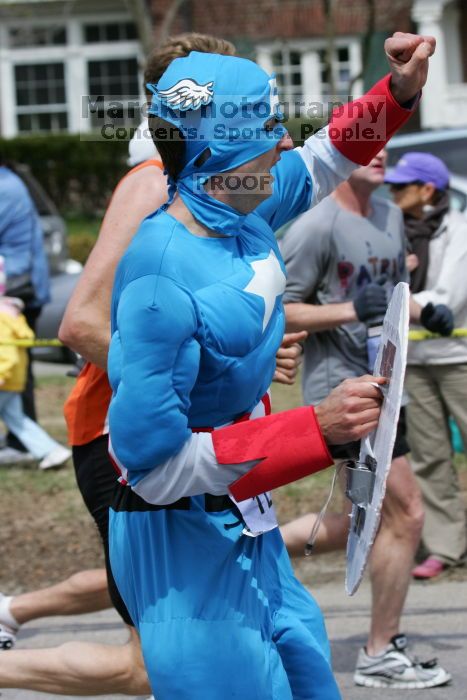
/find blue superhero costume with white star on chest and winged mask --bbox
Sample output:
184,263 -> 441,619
108,53 -> 414,700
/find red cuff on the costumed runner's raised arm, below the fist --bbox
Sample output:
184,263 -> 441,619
329,75 -> 419,165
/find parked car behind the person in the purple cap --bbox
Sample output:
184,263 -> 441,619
387,129 -> 467,216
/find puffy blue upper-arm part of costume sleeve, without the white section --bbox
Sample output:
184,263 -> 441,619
109,275 -> 199,472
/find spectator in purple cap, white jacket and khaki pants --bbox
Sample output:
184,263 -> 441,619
386,152 -> 467,579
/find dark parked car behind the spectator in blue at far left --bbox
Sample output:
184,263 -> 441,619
14,165 -> 82,362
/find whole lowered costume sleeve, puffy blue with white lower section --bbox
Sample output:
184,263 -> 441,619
108,275 -> 256,505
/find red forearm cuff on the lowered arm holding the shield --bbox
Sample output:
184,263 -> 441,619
212,406 -> 333,501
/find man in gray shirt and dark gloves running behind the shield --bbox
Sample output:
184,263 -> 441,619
281,151 -> 450,689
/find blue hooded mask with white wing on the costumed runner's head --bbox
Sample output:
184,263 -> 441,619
148,51 -> 287,236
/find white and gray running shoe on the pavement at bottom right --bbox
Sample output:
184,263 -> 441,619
354,634 -> 451,690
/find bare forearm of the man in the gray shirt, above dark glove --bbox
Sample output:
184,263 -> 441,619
285,301 -> 357,333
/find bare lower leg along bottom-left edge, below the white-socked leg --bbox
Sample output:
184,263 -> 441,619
0,628 -> 151,696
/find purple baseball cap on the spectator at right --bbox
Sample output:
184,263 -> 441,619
384,151 -> 449,190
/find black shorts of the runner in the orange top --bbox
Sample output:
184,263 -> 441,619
73,435 -> 133,626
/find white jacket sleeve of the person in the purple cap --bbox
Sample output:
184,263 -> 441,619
412,213 -> 467,315
